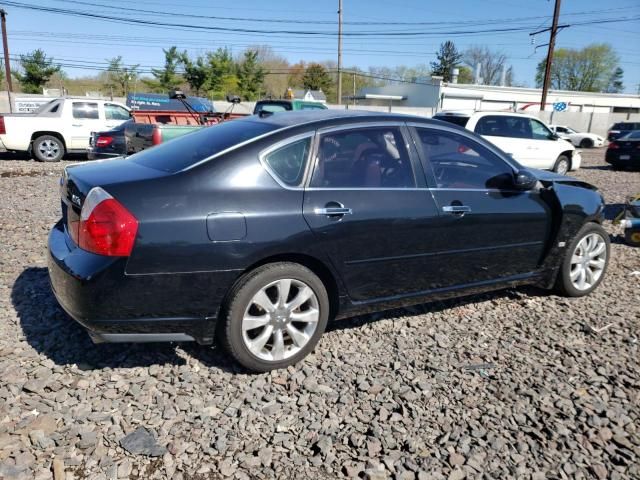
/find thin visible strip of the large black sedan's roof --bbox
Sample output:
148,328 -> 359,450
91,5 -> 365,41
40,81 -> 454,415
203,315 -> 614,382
250,109 -> 440,128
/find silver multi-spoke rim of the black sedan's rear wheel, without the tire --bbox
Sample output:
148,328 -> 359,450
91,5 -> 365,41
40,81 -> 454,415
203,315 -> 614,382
242,278 -> 320,361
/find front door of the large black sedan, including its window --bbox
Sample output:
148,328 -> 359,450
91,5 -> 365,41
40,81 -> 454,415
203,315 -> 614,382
412,125 -> 551,287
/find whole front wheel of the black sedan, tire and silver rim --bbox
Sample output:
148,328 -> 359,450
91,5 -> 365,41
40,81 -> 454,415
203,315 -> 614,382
556,222 -> 611,297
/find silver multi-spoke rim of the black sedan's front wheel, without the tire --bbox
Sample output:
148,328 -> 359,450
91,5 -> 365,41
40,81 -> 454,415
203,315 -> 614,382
569,233 -> 607,290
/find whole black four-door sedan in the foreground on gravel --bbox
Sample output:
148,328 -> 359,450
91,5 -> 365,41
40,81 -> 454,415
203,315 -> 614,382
49,110 -> 609,371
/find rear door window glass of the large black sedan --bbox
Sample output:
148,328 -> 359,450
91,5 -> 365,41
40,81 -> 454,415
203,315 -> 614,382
311,127 -> 416,189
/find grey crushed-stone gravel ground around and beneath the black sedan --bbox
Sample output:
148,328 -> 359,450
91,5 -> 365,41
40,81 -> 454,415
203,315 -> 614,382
0,150 -> 640,480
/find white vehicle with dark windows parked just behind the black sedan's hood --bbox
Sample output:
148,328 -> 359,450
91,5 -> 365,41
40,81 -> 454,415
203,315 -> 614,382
433,111 -> 582,175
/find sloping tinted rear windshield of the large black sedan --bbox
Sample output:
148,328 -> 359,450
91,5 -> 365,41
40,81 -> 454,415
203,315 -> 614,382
130,120 -> 279,173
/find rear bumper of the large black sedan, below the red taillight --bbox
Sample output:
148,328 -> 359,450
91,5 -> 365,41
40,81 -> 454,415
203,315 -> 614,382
48,222 -> 216,344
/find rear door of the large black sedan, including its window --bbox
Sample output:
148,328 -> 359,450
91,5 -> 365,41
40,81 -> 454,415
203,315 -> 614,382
303,123 -> 438,301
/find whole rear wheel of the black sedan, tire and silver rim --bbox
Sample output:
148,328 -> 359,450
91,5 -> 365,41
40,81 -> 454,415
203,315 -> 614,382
218,262 -> 329,372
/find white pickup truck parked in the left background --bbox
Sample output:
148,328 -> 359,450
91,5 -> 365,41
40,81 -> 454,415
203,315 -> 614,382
0,97 -> 131,162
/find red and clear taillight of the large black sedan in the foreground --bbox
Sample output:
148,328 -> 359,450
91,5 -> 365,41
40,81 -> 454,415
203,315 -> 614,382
78,187 -> 138,257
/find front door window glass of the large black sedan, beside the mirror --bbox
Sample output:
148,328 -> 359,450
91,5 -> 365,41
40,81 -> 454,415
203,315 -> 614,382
416,128 -> 513,189
